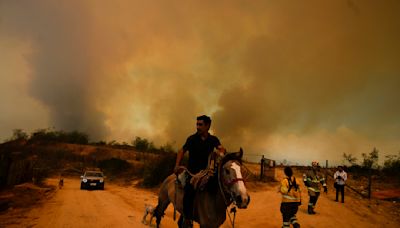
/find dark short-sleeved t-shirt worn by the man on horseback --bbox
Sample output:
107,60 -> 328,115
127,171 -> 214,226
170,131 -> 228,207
183,133 -> 221,173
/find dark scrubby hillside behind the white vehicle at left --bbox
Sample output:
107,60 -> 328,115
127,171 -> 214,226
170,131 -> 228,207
0,140 -> 159,189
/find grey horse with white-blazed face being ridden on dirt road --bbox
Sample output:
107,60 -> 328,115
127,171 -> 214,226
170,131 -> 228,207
154,148 -> 250,228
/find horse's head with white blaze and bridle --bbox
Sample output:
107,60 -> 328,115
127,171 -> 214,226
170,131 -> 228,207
219,148 -> 250,208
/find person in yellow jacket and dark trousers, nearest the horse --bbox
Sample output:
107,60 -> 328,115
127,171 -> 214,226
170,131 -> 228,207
279,167 -> 301,228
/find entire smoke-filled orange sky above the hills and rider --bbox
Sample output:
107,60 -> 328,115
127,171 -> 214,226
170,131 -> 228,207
0,0 -> 400,163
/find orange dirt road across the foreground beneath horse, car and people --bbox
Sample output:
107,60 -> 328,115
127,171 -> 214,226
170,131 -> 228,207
2,173 -> 400,228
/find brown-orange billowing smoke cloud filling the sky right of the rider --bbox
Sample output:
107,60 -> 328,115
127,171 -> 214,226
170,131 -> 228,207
215,0 -> 400,161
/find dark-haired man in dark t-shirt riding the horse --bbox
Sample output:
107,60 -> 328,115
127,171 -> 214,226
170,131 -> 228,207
174,115 -> 226,227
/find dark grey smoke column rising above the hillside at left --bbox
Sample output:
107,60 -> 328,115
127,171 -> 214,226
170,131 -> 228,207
2,1 -> 114,139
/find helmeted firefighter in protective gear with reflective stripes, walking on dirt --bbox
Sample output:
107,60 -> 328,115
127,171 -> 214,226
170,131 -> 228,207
304,161 -> 328,215
